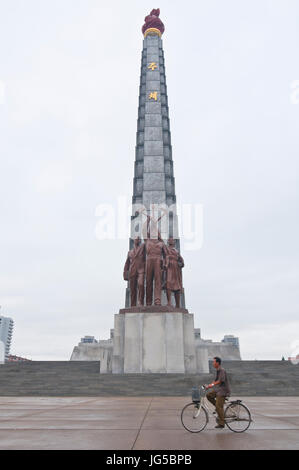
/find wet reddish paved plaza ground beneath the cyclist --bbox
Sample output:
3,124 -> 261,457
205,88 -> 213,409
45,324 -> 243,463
0,397 -> 299,450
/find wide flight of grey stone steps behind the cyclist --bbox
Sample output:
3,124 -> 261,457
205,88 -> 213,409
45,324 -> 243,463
0,361 -> 299,397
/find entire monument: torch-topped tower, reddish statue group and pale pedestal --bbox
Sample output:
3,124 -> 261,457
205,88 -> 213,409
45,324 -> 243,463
112,10 -> 199,373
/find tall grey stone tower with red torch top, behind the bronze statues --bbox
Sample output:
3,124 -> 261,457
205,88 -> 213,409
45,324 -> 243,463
125,10 -> 185,308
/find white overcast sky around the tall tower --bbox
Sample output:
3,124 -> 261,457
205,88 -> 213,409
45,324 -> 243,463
0,0 -> 299,360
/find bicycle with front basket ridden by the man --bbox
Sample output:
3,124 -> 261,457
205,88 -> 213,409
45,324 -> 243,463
181,385 -> 252,433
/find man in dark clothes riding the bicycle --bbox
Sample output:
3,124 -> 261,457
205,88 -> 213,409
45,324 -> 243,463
205,356 -> 230,429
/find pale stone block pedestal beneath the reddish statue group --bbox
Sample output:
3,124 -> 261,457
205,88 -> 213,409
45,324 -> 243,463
112,306 -> 197,374
